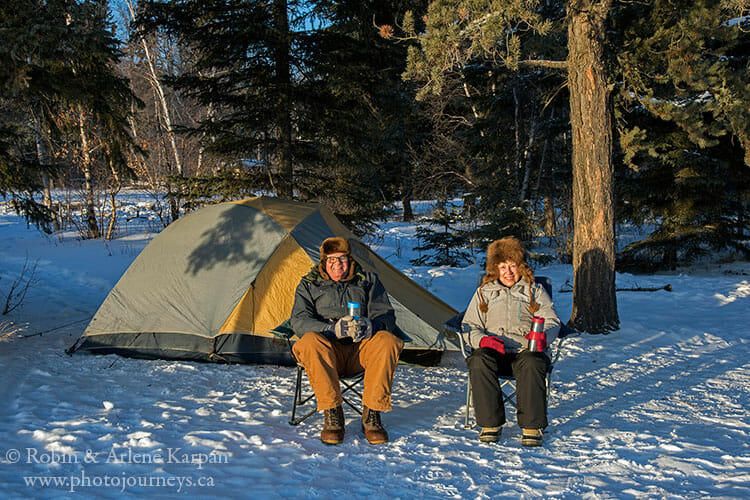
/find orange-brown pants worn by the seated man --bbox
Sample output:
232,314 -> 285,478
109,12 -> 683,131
292,330 -> 404,411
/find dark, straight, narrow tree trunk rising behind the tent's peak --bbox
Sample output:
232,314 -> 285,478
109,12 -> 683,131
274,0 -> 294,200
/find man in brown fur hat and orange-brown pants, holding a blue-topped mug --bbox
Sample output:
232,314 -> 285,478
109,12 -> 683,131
291,237 -> 404,444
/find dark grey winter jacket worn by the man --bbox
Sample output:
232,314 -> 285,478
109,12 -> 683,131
291,261 -> 396,337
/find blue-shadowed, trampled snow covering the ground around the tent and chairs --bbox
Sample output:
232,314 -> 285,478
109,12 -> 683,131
0,196 -> 750,499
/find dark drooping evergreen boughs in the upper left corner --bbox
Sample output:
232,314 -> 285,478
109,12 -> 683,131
0,0 -> 133,229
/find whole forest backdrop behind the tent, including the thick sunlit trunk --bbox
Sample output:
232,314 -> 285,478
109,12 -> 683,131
0,0 -> 750,333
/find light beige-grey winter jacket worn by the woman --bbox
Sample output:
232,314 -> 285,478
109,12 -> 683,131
461,279 -> 560,353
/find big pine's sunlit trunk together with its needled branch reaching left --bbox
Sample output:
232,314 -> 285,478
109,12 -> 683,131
390,0 -> 619,332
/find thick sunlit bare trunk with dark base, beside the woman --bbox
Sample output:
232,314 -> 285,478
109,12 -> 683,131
568,0 -> 620,333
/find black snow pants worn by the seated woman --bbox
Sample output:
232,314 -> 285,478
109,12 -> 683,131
466,347 -> 550,429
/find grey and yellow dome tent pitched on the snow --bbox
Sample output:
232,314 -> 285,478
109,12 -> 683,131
69,196 -> 456,365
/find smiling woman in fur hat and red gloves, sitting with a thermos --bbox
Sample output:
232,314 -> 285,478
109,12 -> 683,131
462,237 -> 560,446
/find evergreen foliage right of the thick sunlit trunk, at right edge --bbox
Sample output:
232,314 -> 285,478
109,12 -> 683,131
618,0 -> 750,270
